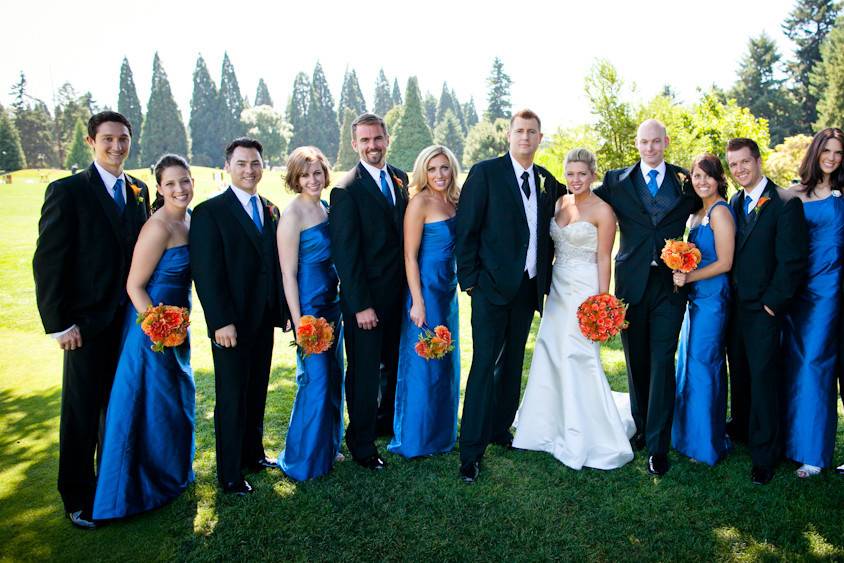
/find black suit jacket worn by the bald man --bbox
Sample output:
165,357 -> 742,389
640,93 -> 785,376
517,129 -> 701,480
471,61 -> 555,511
595,162 -> 701,305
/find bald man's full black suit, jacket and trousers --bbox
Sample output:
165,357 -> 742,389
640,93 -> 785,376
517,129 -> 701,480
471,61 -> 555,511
595,163 -> 700,455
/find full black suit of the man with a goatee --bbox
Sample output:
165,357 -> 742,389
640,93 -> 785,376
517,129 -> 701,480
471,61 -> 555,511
328,163 -> 407,460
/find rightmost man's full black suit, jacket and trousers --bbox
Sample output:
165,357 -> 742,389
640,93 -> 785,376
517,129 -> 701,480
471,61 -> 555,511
727,180 -> 809,468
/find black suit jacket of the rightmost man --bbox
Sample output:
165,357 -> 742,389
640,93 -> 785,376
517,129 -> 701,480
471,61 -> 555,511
730,179 -> 809,313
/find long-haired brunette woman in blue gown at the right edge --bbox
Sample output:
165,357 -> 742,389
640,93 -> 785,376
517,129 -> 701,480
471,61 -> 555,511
783,128 -> 844,478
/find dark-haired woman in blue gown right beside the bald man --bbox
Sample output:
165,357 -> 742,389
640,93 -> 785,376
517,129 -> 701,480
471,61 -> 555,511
671,154 -> 736,465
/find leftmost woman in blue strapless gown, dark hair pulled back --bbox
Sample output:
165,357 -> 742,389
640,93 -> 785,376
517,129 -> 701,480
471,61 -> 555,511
94,154 -> 196,520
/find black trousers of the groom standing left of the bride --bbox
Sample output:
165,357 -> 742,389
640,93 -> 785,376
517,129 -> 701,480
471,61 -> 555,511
460,274 -> 537,464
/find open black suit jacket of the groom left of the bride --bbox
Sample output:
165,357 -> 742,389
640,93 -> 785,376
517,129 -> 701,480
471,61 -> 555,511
455,153 -> 565,313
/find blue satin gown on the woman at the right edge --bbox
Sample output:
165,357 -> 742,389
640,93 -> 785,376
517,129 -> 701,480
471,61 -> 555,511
783,196 -> 844,467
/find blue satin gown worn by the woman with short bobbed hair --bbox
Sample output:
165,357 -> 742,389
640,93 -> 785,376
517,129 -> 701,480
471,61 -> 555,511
279,221 -> 343,481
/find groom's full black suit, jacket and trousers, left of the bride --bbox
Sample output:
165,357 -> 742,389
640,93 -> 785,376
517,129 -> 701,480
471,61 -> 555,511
455,154 -> 565,464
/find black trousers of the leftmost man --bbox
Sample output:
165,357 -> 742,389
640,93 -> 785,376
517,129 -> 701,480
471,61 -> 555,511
58,314 -> 123,512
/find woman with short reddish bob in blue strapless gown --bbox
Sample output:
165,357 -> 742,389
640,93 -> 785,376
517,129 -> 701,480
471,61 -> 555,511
277,147 -> 343,481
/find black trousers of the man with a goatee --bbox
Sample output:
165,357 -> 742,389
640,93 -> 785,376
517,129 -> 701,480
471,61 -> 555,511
343,298 -> 402,460
